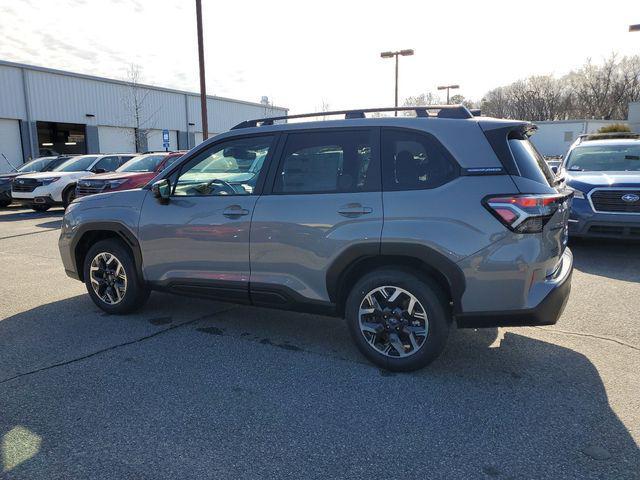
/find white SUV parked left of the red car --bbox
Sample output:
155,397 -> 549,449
11,154 -> 134,212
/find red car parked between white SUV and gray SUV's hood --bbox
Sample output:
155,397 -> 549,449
76,150 -> 186,197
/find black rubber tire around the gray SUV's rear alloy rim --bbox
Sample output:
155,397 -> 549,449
345,268 -> 451,372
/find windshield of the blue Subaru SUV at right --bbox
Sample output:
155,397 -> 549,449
565,142 -> 640,172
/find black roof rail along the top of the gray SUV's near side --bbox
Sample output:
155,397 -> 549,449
231,105 -> 473,130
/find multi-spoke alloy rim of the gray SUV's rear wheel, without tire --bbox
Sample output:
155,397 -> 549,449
358,286 -> 429,358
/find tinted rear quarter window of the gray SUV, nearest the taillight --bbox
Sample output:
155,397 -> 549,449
382,129 -> 459,190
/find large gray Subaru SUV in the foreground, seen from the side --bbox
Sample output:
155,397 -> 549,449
60,106 -> 573,370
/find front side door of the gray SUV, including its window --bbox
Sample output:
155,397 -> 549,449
139,135 -> 275,301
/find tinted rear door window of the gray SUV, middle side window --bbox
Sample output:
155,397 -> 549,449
274,130 -> 380,193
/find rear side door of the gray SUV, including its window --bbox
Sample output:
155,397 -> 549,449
251,128 -> 382,308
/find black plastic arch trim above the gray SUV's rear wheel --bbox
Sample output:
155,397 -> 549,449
326,242 -> 466,314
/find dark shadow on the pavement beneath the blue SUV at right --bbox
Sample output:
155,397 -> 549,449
570,240 -> 640,282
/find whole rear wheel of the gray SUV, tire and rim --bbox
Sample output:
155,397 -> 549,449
345,268 -> 450,371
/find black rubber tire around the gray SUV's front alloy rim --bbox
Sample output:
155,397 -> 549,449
83,239 -> 150,315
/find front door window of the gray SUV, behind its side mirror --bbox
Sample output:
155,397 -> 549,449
173,136 -> 273,196
